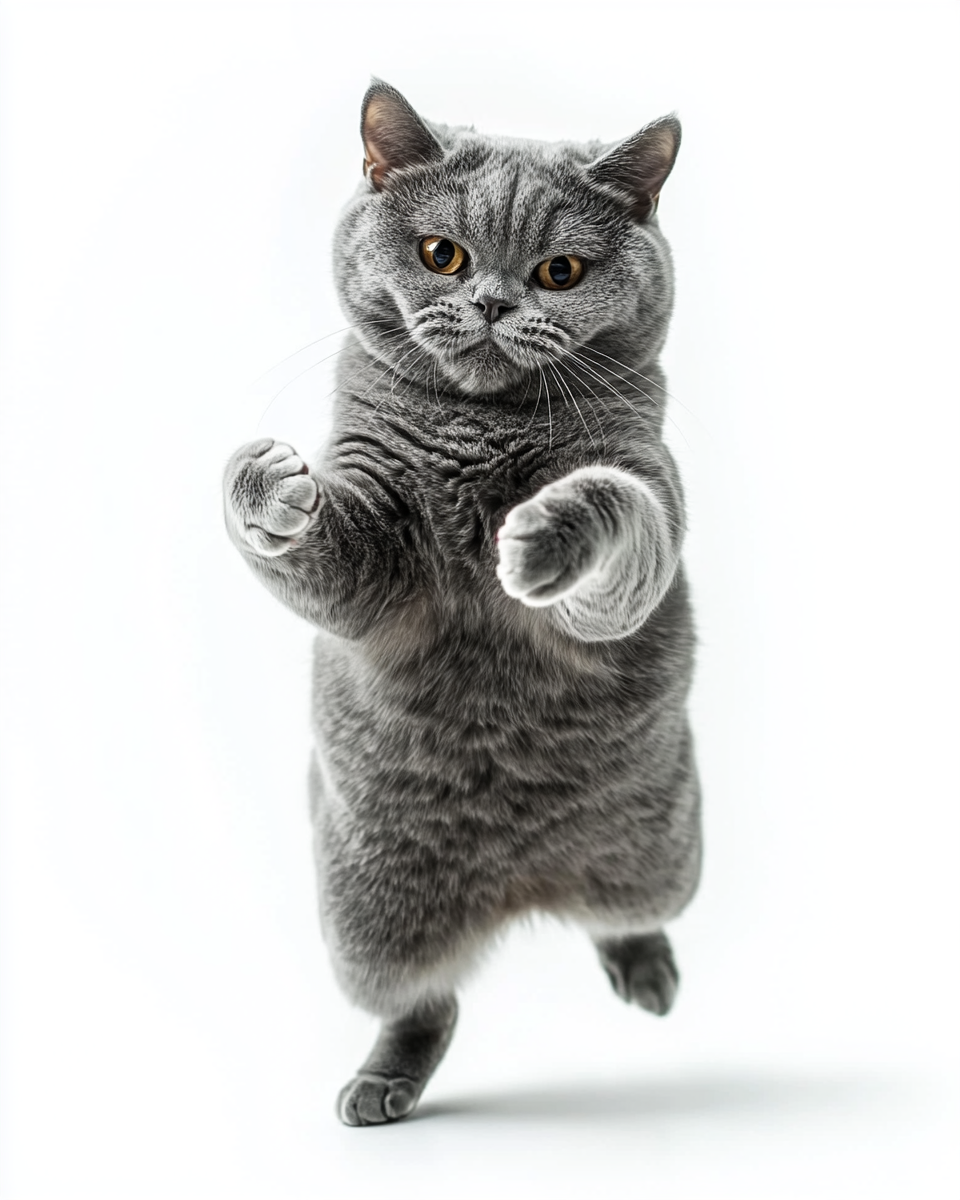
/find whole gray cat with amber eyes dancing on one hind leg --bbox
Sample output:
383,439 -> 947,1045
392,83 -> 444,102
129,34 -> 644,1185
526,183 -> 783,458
224,82 -> 701,1126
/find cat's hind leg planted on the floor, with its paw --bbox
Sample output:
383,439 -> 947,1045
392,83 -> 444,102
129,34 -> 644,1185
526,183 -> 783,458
337,995 -> 457,1126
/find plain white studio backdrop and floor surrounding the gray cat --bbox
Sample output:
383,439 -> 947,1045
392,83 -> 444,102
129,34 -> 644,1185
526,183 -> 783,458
0,0 -> 960,1200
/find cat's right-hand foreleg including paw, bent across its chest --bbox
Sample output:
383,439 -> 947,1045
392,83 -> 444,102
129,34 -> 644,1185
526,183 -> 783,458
498,464 -> 683,642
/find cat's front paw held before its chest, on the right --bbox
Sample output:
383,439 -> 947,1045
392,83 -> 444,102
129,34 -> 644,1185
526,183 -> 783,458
497,480 -> 604,607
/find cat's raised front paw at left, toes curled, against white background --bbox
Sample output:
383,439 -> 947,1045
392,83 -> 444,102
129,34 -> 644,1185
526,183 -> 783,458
223,438 -> 322,558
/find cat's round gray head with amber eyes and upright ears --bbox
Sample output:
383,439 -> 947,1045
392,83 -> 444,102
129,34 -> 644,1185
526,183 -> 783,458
335,82 -> 680,395
